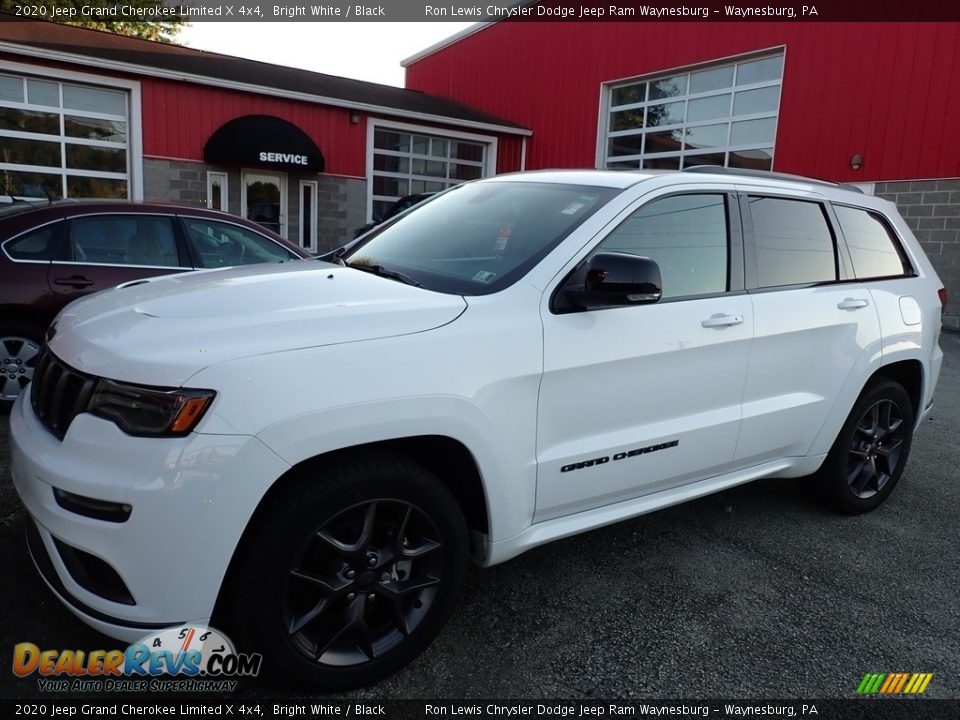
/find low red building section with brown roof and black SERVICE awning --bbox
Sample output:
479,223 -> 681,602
0,15 -> 530,252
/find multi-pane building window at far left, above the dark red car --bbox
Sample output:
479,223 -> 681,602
0,74 -> 130,199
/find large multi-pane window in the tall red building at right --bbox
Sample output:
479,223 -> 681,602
599,53 -> 783,170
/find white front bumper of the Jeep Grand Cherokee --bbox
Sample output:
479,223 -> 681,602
10,393 -> 289,641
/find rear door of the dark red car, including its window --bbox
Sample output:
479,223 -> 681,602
48,213 -> 192,306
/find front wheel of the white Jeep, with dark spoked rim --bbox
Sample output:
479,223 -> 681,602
226,455 -> 468,691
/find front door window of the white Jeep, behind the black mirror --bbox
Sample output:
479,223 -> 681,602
598,195 -> 727,298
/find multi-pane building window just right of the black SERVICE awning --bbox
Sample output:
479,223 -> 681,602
369,125 -> 493,222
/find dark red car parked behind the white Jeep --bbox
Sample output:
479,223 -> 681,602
0,200 -> 310,410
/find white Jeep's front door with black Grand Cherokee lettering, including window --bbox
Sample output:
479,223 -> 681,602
536,189 -> 753,521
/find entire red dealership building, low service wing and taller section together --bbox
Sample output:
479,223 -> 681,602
0,16 -> 960,316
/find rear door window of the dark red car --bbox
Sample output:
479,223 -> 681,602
64,215 -> 182,267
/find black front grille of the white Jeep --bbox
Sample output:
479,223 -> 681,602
30,346 -> 97,440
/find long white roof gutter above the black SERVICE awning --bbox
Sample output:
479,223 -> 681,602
0,41 -> 533,137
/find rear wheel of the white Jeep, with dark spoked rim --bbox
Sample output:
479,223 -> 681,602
816,379 -> 914,515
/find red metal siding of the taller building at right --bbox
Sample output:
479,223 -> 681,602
407,22 -> 960,182
